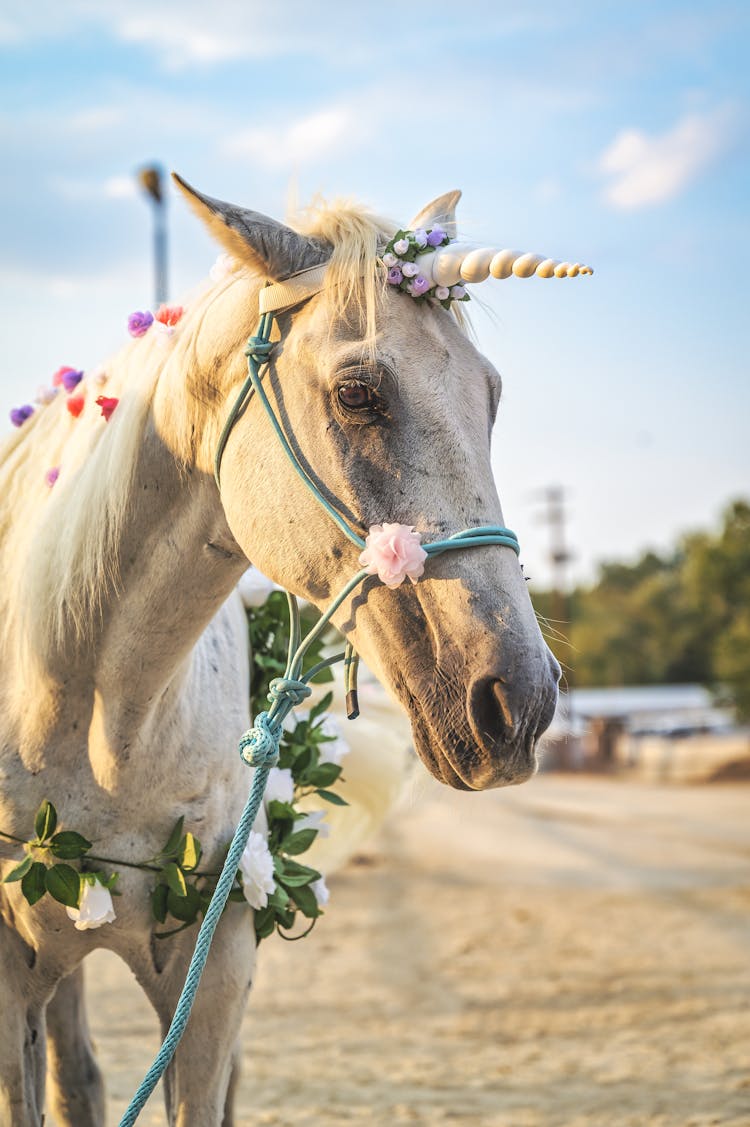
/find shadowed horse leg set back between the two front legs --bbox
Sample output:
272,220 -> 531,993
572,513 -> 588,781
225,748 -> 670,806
47,966 -> 105,1127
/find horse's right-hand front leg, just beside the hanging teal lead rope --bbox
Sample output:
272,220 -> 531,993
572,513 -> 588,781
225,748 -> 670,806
133,905 -> 255,1127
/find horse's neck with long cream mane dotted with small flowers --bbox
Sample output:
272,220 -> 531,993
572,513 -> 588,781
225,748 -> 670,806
3,284 -> 257,709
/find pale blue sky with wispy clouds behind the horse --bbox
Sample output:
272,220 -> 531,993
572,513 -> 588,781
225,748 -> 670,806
0,0 -> 750,584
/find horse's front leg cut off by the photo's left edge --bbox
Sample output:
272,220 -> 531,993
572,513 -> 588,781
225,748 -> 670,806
0,925 -> 45,1127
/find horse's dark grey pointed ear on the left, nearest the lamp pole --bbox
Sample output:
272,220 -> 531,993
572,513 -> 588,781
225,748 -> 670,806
171,172 -> 330,282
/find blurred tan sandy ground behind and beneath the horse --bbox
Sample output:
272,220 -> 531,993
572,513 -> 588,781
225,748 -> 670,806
78,775 -> 750,1127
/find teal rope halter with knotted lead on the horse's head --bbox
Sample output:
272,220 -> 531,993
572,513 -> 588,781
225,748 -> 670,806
120,313 -> 520,1127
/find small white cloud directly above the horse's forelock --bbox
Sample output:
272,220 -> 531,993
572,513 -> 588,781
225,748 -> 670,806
222,106 -> 363,168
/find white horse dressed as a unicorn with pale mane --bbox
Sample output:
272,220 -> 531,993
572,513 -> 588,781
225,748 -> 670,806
0,180 -> 559,1127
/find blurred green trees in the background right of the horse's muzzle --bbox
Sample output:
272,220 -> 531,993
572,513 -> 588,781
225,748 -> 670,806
525,500 -> 750,718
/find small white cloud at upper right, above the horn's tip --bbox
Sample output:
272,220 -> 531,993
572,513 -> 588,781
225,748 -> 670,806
599,106 -> 735,211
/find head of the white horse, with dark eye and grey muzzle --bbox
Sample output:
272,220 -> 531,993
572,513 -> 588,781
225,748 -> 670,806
172,181 -> 566,790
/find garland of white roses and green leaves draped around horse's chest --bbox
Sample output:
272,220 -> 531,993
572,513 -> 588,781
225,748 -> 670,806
0,584 -> 348,942
